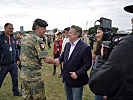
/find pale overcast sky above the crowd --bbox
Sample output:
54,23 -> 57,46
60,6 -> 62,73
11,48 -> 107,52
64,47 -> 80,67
0,0 -> 133,31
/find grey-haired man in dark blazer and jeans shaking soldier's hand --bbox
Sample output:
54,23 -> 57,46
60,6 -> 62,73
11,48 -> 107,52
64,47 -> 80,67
56,25 -> 92,100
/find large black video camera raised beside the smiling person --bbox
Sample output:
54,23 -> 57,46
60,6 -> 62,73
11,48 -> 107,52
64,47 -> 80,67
94,17 -> 125,60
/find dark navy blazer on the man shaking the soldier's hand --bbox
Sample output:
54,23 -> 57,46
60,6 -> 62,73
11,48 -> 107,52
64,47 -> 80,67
59,40 -> 92,87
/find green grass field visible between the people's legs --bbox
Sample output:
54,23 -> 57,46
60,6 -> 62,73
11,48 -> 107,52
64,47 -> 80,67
0,40 -> 94,100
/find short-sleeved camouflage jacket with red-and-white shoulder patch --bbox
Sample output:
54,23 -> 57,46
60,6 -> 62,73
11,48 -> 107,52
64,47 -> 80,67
21,32 -> 48,81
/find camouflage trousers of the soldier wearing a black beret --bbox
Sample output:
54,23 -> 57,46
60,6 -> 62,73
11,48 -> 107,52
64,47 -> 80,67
21,79 -> 46,100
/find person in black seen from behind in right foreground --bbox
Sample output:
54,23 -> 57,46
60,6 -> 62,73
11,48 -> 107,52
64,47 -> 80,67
89,5 -> 133,100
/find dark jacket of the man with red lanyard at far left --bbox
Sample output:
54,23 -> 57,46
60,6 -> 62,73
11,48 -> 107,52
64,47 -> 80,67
0,32 -> 20,65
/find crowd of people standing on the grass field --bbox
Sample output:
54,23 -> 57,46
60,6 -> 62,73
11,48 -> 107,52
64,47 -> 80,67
0,6 -> 133,100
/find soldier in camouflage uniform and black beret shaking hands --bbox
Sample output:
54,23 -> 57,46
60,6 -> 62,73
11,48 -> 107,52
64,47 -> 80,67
20,19 -> 56,100
